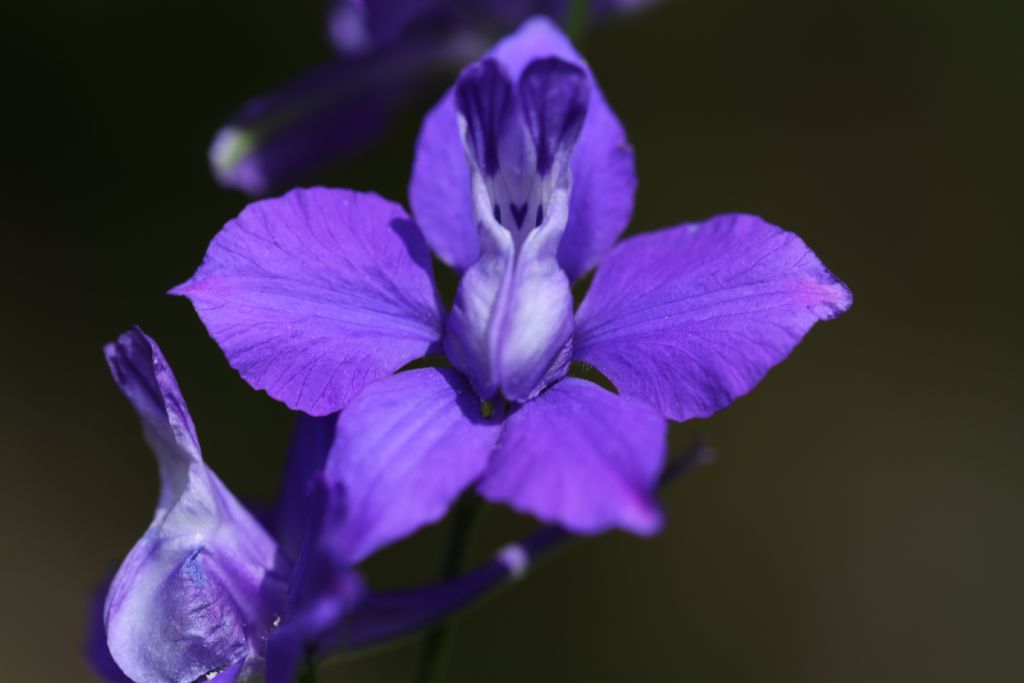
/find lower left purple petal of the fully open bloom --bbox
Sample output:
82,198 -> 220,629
327,368 -> 498,564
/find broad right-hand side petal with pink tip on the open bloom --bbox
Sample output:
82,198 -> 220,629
573,214 -> 852,421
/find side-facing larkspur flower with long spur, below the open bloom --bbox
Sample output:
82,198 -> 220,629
94,329 -> 558,683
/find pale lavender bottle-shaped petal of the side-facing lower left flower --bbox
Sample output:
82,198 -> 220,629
104,329 -> 290,683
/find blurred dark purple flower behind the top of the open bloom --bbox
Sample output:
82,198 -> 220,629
209,0 -> 651,196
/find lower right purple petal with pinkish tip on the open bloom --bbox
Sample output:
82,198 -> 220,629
477,377 -> 667,535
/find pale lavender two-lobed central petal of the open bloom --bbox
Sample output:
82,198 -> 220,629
444,58 -> 589,401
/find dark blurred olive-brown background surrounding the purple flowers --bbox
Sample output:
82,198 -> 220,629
0,0 -> 1024,683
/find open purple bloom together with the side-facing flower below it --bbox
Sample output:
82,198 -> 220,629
96,12 -> 851,683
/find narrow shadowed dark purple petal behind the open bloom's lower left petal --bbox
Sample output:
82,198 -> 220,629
272,413 -> 338,561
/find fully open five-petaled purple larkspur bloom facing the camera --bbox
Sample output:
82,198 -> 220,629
180,18 -> 851,561
